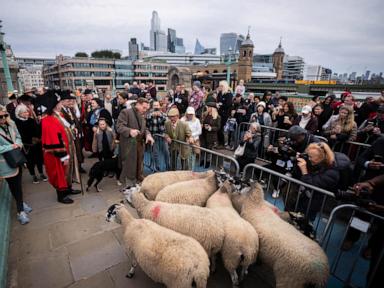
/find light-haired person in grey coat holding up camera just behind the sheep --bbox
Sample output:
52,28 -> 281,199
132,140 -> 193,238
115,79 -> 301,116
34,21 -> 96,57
237,122 -> 261,172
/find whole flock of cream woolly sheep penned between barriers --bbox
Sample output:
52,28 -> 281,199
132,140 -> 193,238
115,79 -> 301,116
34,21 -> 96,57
107,171 -> 329,288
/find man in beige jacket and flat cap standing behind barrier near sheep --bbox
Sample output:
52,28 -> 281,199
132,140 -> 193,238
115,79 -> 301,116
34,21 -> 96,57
165,108 -> 193,170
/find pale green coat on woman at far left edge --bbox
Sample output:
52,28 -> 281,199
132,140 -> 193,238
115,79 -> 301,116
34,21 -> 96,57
0,122 -> 23,179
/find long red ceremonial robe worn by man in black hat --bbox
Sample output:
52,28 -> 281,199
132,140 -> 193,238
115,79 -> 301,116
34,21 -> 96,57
41,114 -> 74,190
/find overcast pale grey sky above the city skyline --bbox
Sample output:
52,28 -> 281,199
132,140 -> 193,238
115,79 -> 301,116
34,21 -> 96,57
0,0 -> 384,73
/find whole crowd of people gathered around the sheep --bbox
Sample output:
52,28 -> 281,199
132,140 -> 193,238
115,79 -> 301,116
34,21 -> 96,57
0,81 -> 384,284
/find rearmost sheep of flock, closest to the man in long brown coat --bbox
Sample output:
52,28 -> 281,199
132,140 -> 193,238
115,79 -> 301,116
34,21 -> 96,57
125,171 -> 209,200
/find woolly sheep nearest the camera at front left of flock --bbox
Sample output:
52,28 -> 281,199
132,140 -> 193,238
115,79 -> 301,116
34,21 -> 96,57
107,204 -> 209,288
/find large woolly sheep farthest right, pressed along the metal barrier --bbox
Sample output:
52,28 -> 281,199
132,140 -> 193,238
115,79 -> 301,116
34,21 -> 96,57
231,183 -> 329,288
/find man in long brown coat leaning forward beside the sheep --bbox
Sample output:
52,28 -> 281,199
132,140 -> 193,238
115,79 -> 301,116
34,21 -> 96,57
116,98 -> 154,187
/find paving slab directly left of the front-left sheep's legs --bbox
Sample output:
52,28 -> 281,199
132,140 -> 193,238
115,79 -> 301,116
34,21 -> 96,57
68,232 -> 127,281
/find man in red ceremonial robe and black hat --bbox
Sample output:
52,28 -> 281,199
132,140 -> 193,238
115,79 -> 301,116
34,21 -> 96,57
41,91 -> 81,204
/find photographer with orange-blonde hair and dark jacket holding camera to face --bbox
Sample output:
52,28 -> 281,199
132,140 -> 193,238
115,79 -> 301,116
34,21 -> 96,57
297,143 -> 351,222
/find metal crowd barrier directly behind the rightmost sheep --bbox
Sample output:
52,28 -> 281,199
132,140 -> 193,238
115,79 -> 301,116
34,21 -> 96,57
243,163 -> 336,239
